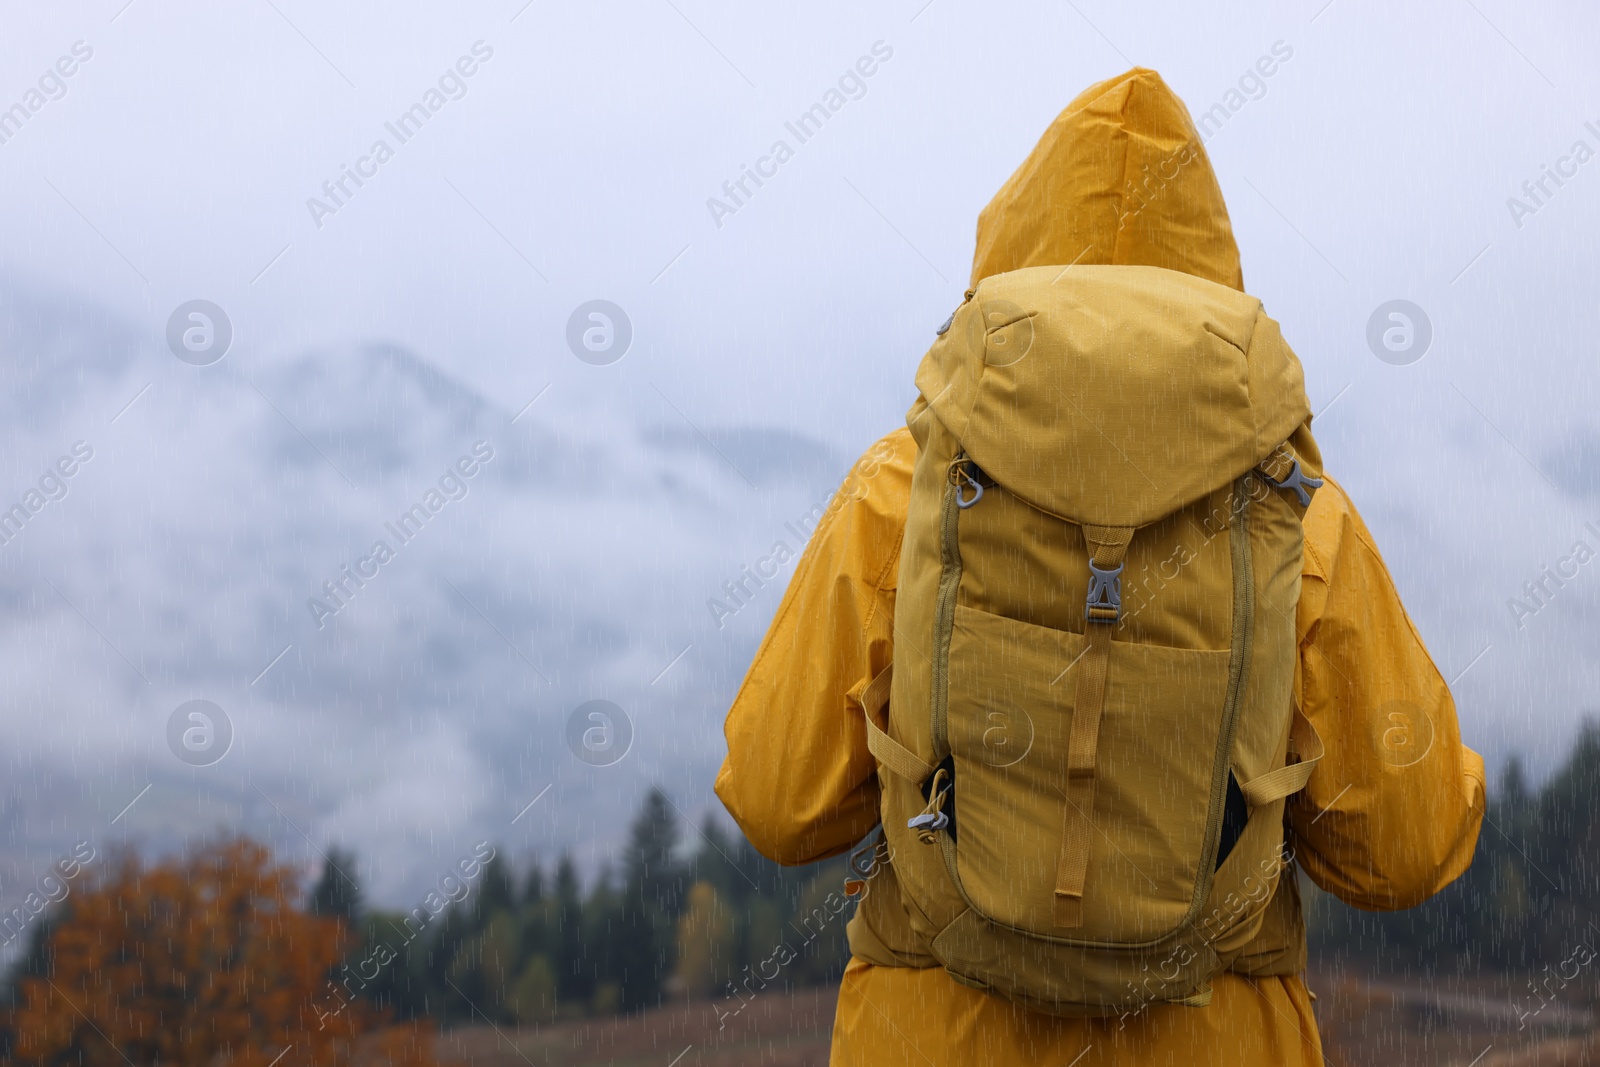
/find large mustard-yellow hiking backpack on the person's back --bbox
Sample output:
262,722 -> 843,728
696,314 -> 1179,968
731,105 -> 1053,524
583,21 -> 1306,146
851,266 -> 1322,1016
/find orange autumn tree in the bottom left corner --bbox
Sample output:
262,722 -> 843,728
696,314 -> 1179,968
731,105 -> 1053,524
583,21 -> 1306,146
6,838 -> 434,1067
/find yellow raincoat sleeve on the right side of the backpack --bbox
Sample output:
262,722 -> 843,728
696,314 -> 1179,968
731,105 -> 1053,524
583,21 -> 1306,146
1288,478 -> 1485,910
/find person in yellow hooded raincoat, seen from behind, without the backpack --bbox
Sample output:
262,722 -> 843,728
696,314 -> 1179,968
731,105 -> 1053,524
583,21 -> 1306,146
717,69 -> 1485,1067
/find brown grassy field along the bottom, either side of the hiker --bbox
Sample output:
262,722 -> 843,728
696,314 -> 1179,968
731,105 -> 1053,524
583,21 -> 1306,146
438,974 -> 1600,1067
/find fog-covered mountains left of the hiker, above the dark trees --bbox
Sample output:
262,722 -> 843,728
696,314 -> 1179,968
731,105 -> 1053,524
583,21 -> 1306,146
0,285 -> 848,921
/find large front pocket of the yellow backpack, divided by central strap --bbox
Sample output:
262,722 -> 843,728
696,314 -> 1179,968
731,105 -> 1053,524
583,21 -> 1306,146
947,605 -> 1229,945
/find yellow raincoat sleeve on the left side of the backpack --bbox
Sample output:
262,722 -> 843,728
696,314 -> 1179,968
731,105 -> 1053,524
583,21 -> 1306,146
717,429 -> 917,864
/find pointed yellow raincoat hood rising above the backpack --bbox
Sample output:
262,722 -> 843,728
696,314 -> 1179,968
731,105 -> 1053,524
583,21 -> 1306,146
971,67 -> 1245,290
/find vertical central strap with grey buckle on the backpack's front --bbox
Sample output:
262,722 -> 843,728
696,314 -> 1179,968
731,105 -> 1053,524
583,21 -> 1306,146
1054,525 -> 1133,928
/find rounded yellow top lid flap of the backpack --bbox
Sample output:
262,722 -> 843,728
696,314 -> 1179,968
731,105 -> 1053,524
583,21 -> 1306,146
917,266 -> 1310,526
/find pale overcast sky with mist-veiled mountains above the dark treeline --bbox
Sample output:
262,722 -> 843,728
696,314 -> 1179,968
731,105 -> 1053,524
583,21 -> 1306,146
0,0 -> 1600,905
